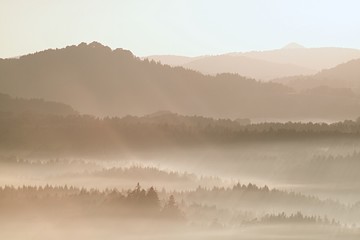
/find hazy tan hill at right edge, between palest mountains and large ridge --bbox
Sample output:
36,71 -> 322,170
274,59 -> 360,93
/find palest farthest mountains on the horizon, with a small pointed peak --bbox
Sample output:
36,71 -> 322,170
148,43 -> 360,81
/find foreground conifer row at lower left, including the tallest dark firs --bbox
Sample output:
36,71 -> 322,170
0,184 -> 184,219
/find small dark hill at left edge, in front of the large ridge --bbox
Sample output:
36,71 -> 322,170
0,93 -> 77,116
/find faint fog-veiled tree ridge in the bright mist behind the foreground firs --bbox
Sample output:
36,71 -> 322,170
0,158 -> 223,186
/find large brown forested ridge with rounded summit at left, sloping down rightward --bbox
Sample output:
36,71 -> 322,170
0,42 -> 360,120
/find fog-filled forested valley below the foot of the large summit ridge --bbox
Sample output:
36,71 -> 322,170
0,96 -> 360,240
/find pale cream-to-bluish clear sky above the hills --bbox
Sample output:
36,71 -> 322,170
0,0 -> 360,58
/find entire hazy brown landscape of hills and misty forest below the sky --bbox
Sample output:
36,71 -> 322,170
0,42 -> 360,240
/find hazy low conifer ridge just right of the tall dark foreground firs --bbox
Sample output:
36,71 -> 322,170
172,183 -> 351,216
